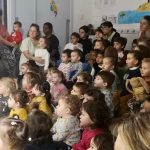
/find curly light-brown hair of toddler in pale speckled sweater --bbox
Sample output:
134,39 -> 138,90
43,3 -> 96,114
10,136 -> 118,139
60,94 -> 81,116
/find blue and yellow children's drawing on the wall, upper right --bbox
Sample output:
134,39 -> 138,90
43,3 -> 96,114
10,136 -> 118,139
118,0 -> 150,24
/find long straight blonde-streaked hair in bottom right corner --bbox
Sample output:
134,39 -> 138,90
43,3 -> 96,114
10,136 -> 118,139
118,112 -> 150,150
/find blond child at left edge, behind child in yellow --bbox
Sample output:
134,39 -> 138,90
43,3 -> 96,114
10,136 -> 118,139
0,77 -> 16,117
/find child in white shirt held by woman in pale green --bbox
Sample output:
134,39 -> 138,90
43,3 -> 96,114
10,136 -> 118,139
34,37 -> 50,72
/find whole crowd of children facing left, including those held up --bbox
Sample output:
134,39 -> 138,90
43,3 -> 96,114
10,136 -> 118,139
0,16 -> 150,150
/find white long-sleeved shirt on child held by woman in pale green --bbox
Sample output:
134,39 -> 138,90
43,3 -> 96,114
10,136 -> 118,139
34,49 -> 50,70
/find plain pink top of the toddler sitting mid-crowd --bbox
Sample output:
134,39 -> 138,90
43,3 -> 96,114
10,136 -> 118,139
51,83 -> 68,105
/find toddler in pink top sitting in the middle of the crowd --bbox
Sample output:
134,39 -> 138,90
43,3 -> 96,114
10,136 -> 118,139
51,70 -> 68,106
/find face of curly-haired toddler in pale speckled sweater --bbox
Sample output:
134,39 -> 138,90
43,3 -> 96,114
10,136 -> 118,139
56,99 -> 70,117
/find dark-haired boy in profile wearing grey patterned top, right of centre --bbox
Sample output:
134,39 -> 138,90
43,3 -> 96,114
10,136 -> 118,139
94,71 -> 115,117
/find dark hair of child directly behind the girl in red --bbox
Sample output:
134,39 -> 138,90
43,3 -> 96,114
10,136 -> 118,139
84,87 -> 105,101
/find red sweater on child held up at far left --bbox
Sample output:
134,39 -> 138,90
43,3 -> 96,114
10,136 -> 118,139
7,31 -> 22,44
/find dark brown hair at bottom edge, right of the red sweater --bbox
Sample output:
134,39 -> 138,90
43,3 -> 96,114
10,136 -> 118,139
93,133 -> 114,150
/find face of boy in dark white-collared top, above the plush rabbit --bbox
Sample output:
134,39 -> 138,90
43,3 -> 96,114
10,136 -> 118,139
126,53 -> 138,68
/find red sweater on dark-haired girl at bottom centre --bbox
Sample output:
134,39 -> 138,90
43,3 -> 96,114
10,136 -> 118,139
72,128 -> 104,150
